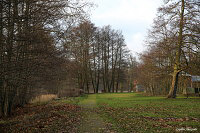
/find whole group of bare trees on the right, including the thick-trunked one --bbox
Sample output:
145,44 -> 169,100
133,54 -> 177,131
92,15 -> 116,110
138,0 -> 200,98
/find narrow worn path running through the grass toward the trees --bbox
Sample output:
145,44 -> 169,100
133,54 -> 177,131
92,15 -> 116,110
79,95 -> 114,133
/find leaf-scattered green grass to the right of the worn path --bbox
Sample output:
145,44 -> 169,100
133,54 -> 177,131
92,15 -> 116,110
88,93 -> 200,133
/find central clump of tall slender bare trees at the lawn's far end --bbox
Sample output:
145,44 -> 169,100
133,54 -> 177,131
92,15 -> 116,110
63,21 -> 132,93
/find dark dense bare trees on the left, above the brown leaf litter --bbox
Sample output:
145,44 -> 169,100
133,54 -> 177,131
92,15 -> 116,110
0,0 -> 91,116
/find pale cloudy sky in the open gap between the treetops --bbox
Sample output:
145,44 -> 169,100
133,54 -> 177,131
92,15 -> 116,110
91,0 -> 162,55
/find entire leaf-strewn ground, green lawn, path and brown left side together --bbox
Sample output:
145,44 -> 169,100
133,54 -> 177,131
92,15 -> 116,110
0,93 -> 200,133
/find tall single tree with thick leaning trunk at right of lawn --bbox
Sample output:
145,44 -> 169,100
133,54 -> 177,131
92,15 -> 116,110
141,0 -> 200,98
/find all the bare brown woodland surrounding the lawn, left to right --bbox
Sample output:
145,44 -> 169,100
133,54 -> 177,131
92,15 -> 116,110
0,0 -> 200,116
